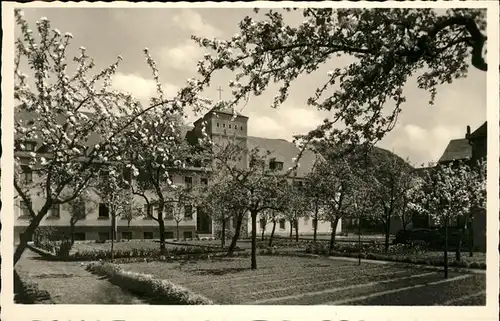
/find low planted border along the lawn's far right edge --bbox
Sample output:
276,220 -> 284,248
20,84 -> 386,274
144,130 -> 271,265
305,244 -> 486,270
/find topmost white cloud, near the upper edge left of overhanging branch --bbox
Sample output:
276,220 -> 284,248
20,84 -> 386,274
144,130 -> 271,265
172,9 -> 222,38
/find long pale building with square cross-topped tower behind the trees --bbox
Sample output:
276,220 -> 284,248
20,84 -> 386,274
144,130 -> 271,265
14,110 -> 341,242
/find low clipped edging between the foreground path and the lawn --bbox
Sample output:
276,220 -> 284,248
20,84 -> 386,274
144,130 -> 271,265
86,262 -> 213,305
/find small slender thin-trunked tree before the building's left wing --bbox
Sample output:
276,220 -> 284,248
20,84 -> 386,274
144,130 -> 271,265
94,165 -> 132,260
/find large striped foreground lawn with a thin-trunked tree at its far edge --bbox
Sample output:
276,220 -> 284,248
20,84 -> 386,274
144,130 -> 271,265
121,256 -> 486,305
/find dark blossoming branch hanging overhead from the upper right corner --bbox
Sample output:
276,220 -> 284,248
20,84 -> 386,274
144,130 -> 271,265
184,8 -> 487,142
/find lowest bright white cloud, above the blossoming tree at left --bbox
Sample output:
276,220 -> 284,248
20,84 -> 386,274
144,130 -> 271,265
112,73 -> 179,104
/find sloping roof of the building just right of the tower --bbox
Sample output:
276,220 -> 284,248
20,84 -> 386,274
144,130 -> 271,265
247,136 -> 321,177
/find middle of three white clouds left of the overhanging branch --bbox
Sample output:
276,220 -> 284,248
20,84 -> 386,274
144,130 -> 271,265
160,41 -> 202,71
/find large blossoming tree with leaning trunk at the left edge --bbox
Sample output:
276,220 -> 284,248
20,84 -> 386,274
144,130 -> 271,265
14,10 -> 204,264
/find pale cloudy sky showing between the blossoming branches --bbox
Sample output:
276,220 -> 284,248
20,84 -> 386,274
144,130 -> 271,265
16,8 -> 486,166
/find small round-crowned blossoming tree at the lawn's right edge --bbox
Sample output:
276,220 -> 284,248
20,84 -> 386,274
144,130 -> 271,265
420,163 -> 485,278
